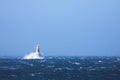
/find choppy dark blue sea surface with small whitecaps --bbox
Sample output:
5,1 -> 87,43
0,57 -> 120,80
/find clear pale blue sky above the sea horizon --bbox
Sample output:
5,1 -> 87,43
0,0 -> 120,56
